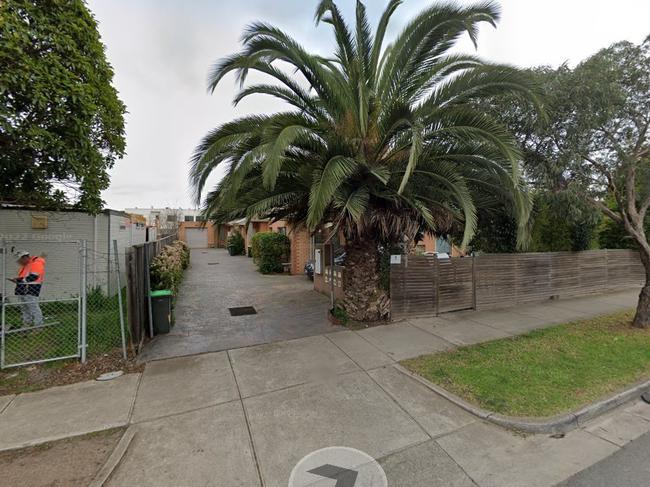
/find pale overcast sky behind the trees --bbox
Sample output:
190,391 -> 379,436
88,0 -> 650,209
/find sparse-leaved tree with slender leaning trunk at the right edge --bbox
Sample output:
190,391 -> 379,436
496,37 -> 650,327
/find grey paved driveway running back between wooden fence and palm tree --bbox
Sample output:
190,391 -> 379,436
142,249 -> 333,361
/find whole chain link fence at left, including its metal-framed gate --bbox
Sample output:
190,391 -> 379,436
0,240 -> 126,368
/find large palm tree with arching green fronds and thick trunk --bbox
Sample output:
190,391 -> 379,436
191,0 -> 538,320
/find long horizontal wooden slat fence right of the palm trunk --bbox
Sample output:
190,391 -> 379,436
390,250 -> 645,318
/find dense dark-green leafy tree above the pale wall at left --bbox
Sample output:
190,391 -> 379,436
0,0 -> 125,212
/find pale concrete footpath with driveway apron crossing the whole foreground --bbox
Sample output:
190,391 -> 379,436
0,291 -> 650,487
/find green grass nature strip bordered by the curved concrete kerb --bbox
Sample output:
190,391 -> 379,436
402,312 -> 650,417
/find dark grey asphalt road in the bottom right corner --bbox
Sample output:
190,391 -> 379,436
558,433 -> 650,487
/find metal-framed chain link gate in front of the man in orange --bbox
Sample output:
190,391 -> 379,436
0,240 -> 86,368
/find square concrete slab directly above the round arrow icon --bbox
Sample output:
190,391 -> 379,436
244,372 -> 429,486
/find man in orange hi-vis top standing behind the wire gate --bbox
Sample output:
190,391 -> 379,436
9,251 -> 45,326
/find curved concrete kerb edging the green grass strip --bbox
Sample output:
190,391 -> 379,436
394,365 -> 650,434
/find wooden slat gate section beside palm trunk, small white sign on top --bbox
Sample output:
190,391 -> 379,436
390,255 -> 476,319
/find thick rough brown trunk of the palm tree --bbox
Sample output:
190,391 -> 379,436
343,240 -> 390,321
